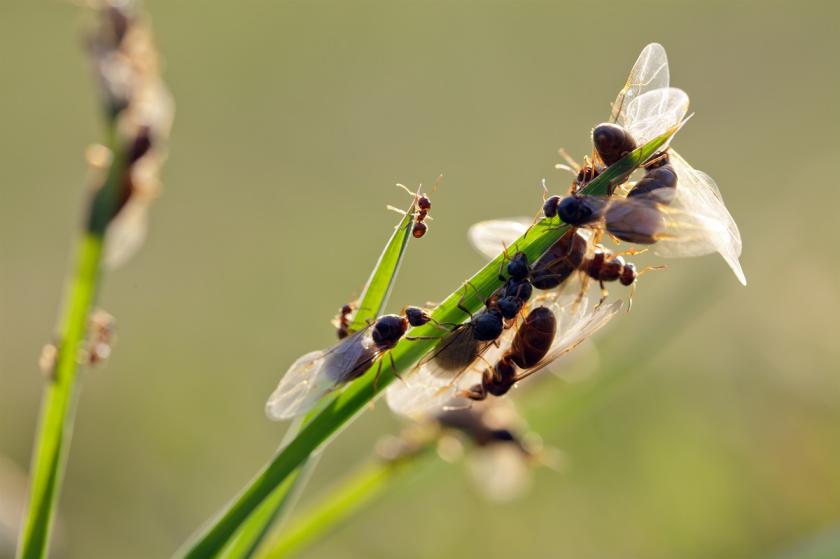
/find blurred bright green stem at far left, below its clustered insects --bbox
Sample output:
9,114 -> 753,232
18,233 -> 103,559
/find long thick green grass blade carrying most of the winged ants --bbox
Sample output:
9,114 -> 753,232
177,128 -> 676,558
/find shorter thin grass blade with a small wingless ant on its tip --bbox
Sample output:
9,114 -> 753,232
221,198 -> 417,559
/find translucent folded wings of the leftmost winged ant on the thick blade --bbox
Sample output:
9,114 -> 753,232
265,330 -> 373,421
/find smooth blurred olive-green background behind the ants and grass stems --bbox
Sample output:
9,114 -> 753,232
0,0 -> 840,559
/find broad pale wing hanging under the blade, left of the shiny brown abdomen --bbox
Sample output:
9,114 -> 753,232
385,320 -> 527,419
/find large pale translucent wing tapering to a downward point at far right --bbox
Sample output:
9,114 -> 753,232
654,150 -> 747,285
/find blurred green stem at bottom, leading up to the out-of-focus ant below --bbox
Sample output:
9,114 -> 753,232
259,450 -> 434,559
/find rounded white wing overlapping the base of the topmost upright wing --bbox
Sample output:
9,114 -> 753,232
618,87 -> 688,145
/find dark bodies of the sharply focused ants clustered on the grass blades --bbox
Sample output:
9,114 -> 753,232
330,123 -> 677,401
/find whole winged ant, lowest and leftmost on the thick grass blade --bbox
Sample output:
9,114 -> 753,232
265,307 -> 432,421
